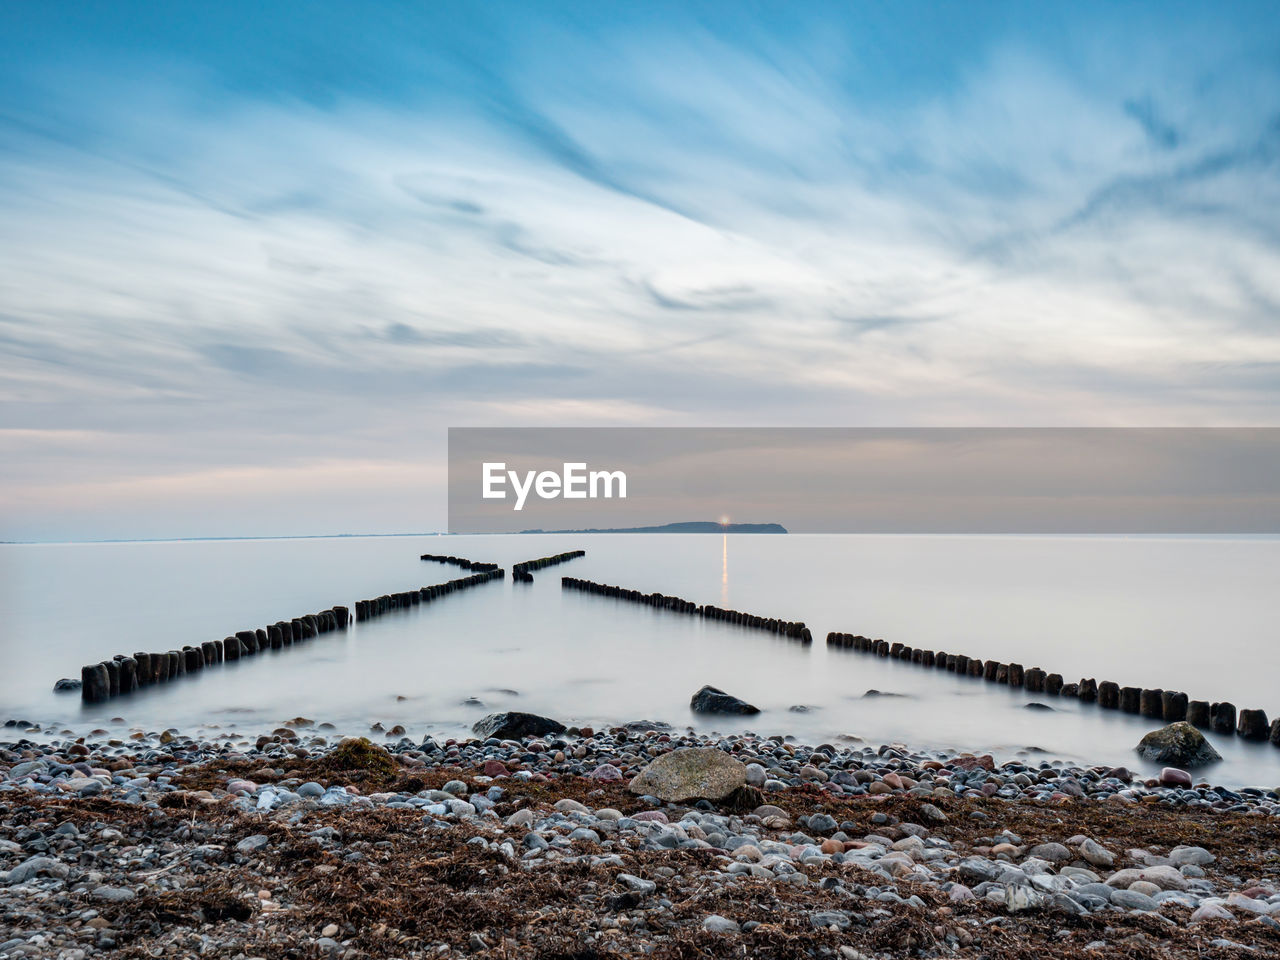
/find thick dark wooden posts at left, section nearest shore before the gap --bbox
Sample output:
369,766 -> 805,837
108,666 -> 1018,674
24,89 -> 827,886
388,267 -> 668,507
81,607 -> 351,703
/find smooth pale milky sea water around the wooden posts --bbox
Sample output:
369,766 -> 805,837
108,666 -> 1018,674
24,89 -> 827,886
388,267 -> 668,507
0,535 -> 1280,786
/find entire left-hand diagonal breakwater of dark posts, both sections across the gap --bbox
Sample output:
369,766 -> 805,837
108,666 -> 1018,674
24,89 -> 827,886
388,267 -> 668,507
81,568 -> 503,703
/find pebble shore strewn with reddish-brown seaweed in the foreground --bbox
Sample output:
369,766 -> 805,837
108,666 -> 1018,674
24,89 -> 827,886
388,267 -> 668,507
0,718 -> 1280,960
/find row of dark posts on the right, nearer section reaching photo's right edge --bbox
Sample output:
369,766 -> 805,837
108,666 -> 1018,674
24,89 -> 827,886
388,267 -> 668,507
827,632 -> 1280,746
